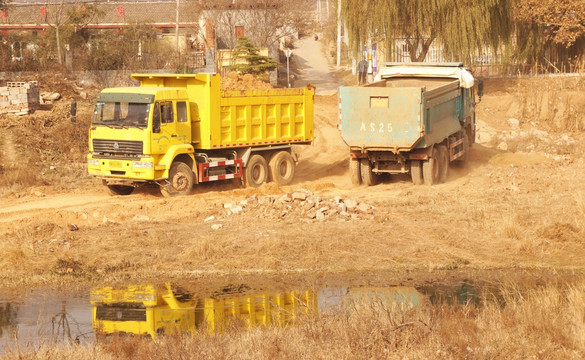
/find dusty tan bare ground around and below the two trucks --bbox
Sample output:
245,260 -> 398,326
0,74 -> 585,294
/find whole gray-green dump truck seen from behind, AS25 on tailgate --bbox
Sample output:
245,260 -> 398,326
338,63 -> 483,185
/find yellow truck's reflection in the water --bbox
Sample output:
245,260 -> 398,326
90,284 -> 317,337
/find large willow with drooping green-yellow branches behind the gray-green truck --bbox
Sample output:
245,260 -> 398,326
341,0 -> 514,61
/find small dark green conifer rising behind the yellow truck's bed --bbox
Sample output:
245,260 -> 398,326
230,37 -> 278,75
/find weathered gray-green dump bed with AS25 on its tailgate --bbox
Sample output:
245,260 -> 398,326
339,77 -> 461,151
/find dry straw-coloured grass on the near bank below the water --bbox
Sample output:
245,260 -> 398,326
3,283 -> 585,360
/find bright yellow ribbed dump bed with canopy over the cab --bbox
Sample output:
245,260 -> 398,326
132,74 -> 314,150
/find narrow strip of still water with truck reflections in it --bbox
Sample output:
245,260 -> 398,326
0,282 -> 480,354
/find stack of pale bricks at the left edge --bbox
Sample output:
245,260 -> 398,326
0,81 -> 39,115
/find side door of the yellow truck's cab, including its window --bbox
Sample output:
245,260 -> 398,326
152,101 -> 178,154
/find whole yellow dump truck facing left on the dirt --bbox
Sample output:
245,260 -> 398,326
84,74 -> 314,196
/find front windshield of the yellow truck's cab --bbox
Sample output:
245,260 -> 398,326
92,102 -> 150,128
